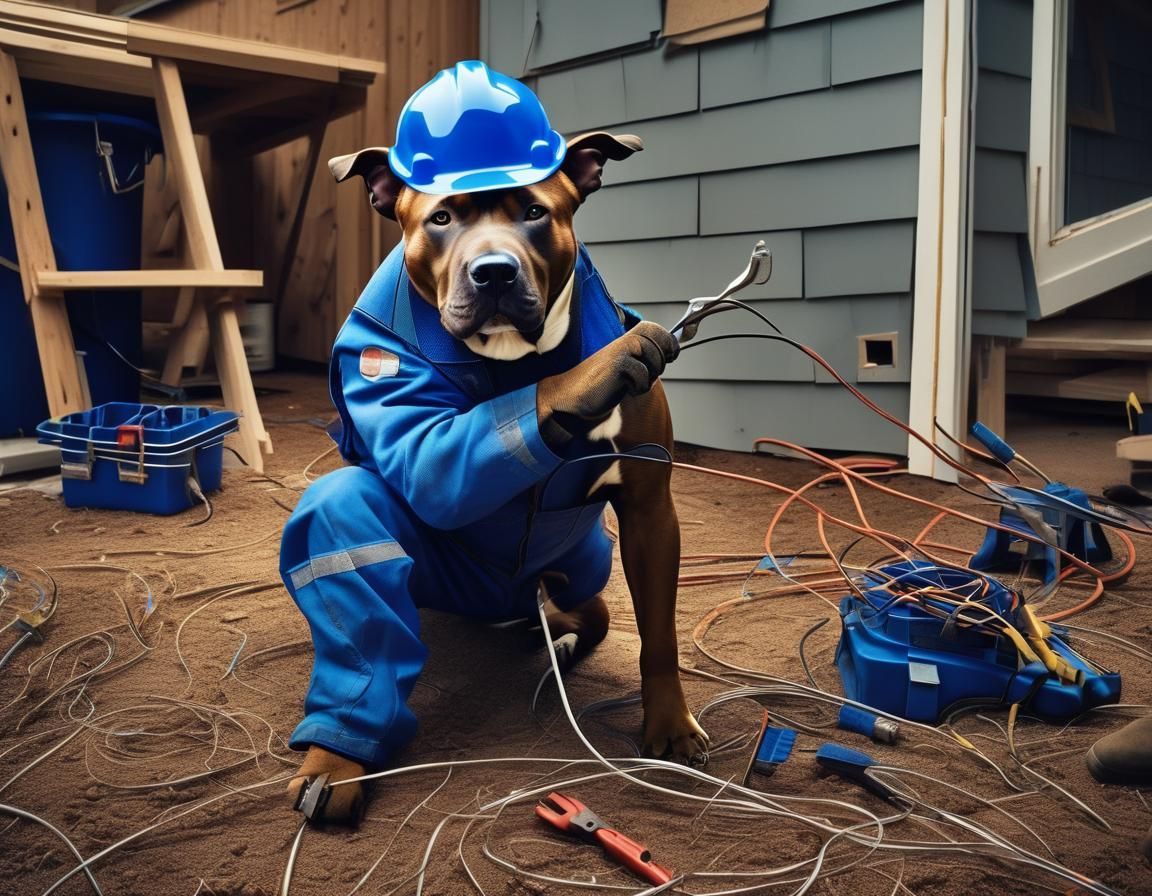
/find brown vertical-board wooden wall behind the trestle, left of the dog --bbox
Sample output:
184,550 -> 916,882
48,0 -> 479,362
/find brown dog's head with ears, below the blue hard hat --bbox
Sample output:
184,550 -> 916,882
328,131 -> 643,360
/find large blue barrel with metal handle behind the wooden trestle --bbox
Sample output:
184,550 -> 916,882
0,109 -> 161,438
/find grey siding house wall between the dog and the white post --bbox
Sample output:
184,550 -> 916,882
480,0 -> 923,454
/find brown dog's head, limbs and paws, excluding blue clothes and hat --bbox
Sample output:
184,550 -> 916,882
290,132 -> 708,819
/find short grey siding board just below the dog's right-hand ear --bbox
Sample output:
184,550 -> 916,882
576,177 -> 695,244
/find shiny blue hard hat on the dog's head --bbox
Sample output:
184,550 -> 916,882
388,61 -> 567,195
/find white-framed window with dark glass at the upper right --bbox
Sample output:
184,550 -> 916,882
1029,0 -> 1152,316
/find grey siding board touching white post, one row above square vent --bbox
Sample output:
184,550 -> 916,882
804,221 -> 916,298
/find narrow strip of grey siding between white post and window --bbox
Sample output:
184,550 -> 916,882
972,0 -> 1032,337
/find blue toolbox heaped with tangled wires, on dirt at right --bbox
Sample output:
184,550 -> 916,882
836,561 -> 1120,724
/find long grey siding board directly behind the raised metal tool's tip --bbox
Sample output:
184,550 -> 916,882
589,232 -> 804,306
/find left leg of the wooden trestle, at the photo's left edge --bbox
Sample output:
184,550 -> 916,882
0,52 -> 84,417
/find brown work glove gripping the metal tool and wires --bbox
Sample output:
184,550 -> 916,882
536,320 -> 680,450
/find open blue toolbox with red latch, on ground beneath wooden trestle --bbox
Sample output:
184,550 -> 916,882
36,402 -> 237,515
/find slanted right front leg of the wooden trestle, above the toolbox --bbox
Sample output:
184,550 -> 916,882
152,59 -> 272,471
